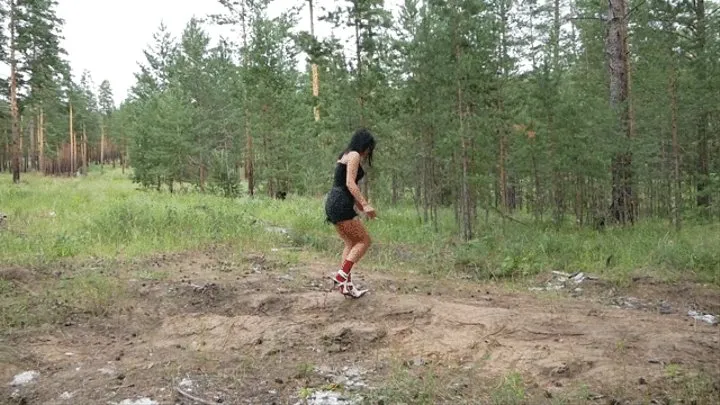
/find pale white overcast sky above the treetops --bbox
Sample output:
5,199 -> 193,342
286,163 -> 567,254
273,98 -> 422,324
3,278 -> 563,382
57,0 -> 400,104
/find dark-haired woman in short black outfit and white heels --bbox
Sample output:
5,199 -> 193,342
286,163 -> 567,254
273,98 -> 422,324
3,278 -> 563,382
325,129 -> 375,298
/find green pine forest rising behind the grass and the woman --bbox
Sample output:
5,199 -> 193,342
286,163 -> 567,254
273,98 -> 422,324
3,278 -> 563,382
0,0 -> 720,234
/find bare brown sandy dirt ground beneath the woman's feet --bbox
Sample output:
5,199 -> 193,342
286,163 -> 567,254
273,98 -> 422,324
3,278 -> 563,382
0,249 -> 720,404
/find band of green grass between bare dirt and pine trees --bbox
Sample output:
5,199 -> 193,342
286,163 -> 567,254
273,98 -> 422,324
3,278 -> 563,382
0,166 -> 720,285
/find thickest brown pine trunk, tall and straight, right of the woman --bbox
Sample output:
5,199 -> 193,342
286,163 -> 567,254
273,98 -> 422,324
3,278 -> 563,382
606,0 -> 635,224
